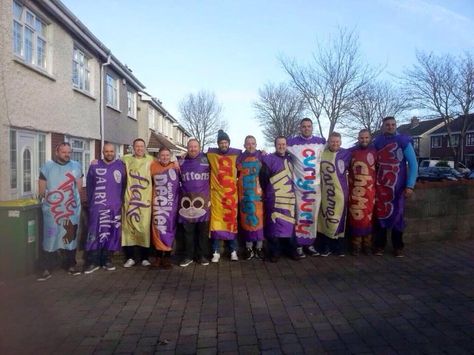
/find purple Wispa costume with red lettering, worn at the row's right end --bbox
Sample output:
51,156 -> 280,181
374,134 -> 411,231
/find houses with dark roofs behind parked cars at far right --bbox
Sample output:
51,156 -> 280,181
398,114 -> 474,168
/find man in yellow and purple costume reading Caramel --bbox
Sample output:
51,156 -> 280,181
318,132 -> 351,256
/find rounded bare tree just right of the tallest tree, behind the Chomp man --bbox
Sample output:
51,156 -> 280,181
344,81 -> 410,134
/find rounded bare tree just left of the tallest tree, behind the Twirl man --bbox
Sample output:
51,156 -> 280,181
253,83 -> 305,144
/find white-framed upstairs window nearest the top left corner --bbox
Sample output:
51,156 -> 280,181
12,1 -> 48,71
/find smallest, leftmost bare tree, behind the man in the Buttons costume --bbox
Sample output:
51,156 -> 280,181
179,90 -> 227,149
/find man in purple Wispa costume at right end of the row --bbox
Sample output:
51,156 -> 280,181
374,117 -> 418,258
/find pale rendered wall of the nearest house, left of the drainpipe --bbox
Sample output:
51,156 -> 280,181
0,0 -> 100,200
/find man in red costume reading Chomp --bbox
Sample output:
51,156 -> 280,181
348,129 -> 377,256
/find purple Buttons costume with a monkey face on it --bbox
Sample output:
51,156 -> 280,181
178,153 -> 211,223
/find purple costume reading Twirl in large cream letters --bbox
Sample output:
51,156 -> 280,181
260,153 -> 296,238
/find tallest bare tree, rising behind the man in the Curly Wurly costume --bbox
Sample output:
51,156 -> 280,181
280,29 -> 378,137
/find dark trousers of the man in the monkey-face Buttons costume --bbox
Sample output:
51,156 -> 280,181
183,221 -> 209,260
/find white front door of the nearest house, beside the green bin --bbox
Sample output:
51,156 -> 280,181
18,131 -> 38,197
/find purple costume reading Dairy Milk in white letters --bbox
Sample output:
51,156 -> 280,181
86,160 -> 125,251
